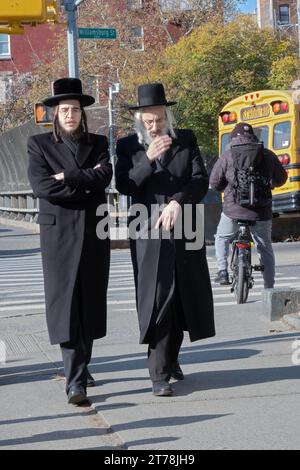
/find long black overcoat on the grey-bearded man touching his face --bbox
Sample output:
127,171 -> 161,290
116,130 -> 215,343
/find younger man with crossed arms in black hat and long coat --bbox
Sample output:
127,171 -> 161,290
28,78 -> 112,404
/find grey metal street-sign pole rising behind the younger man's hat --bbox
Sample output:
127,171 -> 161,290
61,0 -> 84,78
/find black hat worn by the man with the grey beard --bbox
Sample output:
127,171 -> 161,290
129,83 -> 176,110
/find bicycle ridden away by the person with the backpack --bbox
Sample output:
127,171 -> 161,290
230,220 -> 264,304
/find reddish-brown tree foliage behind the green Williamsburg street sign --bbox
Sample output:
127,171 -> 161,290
2,0 -> 236,131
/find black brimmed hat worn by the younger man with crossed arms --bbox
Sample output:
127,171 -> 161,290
43,78 -> 95,107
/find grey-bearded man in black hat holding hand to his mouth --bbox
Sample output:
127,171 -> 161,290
116,83 -> 215,396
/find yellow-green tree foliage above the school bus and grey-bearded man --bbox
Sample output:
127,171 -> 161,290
124,16 -> 300,153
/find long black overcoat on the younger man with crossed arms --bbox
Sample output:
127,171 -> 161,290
28,132 -> 112,344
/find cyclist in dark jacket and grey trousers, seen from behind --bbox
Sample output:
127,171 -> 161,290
210,122 -> 287,289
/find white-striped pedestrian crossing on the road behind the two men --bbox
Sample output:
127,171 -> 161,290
0,250 -> 300,318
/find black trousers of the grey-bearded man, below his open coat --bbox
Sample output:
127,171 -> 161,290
148,303 -> 183,382
